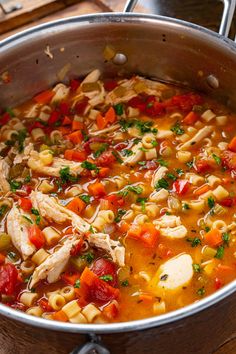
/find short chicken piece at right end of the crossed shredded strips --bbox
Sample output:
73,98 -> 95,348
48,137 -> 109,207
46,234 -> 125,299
88,233 -> 125,267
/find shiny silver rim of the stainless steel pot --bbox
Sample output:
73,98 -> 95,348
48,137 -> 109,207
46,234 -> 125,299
0,13 -> 236,334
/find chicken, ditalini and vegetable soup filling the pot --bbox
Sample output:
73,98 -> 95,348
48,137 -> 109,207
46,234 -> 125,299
0,69 -> 236,325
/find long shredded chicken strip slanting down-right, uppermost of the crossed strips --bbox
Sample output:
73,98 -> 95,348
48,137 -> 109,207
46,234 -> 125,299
30,191 -> 90,233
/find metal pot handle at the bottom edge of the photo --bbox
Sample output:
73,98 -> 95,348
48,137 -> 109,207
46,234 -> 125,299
70,334 -> 111,354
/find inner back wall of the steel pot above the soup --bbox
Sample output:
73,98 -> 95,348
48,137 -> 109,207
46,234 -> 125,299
0,14 -> 236,107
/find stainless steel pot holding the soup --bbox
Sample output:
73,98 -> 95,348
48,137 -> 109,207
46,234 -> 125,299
0,0 -> 236,354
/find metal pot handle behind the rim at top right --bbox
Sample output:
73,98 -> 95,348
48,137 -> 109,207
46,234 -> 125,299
124,0 -> 236,37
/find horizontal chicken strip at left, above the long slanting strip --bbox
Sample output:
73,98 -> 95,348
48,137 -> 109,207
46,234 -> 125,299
28,151 -> 83,177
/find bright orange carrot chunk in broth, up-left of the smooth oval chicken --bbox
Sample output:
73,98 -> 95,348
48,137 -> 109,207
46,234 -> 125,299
127,223 -> 160,248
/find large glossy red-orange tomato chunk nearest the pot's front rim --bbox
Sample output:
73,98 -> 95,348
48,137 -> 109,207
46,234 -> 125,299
80,268 -> 120,304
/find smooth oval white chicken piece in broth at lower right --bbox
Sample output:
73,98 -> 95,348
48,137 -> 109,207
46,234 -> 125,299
151,253 -> 193,293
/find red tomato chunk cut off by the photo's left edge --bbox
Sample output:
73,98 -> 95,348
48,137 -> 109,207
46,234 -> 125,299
0,263 -> 18,295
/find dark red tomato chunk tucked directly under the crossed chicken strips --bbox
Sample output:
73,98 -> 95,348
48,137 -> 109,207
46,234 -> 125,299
91,258 -> 118,287
